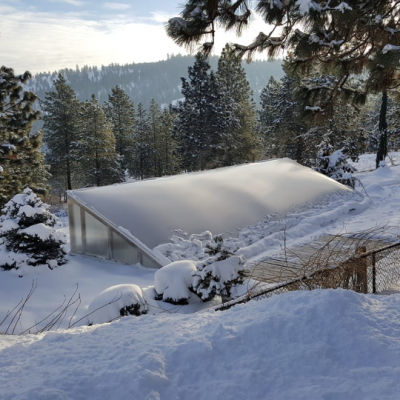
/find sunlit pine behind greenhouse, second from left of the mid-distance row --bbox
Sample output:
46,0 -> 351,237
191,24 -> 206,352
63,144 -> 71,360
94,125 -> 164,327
76,95 -> 124,186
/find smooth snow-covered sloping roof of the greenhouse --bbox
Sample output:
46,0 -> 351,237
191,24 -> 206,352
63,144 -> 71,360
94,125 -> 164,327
70,159 -> 350,249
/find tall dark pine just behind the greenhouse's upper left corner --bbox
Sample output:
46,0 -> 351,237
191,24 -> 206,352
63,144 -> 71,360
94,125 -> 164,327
42,74 -> 81,195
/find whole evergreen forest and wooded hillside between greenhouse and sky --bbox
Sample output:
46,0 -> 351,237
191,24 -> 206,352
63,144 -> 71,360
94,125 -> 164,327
0,1 -> 400,204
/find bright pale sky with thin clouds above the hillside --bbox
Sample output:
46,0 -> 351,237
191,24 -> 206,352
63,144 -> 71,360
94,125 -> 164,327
0,0 -> 263,73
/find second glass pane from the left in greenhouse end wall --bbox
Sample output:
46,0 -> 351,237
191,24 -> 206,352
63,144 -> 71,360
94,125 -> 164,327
85,212 -> 108,258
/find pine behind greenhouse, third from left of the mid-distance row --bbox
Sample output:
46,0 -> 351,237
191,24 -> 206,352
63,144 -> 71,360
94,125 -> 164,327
105,86 -> 136,170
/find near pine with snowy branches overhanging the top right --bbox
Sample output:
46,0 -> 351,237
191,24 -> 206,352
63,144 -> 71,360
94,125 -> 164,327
166,0 -> 400,169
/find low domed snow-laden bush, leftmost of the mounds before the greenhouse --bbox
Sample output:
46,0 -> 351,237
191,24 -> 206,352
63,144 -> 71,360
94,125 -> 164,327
87,284 -> 148,325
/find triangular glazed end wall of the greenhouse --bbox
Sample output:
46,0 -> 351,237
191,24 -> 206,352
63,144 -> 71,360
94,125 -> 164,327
68,198 -> 162,268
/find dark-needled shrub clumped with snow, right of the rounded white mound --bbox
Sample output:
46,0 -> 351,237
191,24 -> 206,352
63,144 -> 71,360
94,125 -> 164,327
193,256 -> 246,301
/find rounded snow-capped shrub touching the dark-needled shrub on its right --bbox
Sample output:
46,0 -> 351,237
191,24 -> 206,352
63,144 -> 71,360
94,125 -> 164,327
154,260 -> 197,304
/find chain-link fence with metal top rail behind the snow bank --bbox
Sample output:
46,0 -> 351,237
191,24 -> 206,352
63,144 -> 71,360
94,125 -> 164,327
215,243 -> 400,310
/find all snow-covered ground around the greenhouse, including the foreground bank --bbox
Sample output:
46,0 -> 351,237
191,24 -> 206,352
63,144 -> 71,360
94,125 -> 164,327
0,153 -> 400,400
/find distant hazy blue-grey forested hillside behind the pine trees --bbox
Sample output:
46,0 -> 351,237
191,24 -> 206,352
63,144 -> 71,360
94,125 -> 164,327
29,55 -> 284,107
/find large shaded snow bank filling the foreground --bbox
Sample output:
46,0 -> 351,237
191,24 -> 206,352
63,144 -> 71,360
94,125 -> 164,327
0,290 -> 400,400
